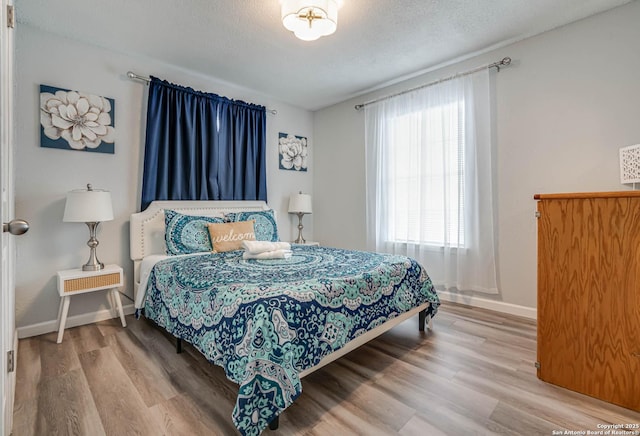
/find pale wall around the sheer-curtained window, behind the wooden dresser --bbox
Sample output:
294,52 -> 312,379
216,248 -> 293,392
314,2 -> 640,308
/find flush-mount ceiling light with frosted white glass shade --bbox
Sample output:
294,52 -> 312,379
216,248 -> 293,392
280,0 -> 342,41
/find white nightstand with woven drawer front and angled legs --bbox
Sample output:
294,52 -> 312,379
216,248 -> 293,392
57,265 -> 127,344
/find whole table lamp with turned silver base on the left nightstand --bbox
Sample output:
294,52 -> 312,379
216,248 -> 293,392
62,184 -> 113,271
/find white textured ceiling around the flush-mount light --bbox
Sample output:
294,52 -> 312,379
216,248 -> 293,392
15,0 -> 635,110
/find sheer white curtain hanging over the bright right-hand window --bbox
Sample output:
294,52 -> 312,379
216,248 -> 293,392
365,69 -> 498,294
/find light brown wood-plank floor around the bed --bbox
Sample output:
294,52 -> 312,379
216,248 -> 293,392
13,304 -> 640,436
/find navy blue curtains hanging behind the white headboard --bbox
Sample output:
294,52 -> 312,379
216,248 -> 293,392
140,77 -> 267,210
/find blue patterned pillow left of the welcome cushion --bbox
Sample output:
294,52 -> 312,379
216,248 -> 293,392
164,209 -> 224,255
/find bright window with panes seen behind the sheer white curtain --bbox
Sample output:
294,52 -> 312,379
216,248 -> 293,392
383,101 -> 465,247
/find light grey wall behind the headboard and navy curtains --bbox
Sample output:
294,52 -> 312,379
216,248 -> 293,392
15,25 -> 314,331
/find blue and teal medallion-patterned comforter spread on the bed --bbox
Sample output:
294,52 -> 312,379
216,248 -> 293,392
144,246 -> 439,435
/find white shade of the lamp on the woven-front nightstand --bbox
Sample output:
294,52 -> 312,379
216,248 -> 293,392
62,189 -> 113,223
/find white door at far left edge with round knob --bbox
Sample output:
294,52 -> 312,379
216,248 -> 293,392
0,0 -> 17,435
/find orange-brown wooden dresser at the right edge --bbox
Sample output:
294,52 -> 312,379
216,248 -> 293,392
534,191 -> 640,411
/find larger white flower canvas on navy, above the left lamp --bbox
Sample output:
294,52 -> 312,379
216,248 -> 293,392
40,85 -> 115,154
